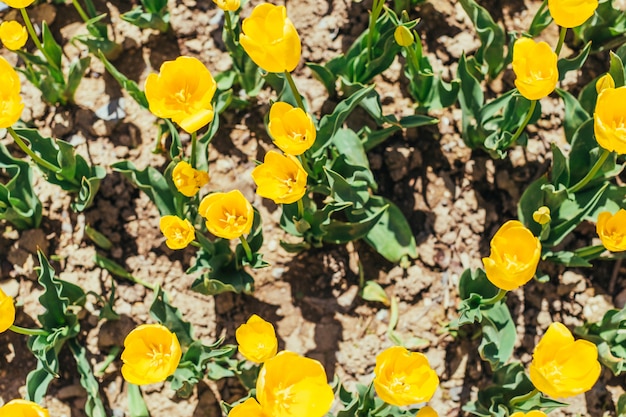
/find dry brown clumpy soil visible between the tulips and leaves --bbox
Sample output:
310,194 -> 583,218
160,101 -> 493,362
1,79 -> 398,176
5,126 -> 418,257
0,0 -> 626,417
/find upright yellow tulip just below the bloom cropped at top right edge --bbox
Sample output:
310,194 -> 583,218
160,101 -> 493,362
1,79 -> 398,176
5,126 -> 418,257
513,38 -> 559,100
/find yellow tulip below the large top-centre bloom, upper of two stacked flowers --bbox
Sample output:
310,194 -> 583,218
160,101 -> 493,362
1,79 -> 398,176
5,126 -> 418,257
267,101 -> 317,155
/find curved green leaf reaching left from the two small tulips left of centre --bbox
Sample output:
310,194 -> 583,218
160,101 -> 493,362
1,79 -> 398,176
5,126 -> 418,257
111,161 -> 176,216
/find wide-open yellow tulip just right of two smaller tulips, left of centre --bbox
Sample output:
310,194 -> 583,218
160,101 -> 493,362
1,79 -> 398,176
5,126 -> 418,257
198,190 -> 254,239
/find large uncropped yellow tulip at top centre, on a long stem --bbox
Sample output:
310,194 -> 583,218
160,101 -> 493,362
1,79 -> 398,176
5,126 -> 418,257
239,3 -> 302,72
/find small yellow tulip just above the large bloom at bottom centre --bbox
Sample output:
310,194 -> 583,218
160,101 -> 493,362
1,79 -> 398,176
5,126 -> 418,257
235,314 -> 278,363
